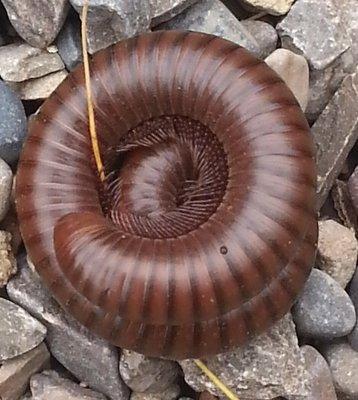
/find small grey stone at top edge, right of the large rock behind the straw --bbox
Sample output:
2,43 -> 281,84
149,0 -> 198,26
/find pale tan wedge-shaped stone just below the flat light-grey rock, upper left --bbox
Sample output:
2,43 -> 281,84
8,70 -> 68,100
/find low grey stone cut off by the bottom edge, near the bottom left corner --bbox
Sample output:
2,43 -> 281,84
30,371 -> 106,400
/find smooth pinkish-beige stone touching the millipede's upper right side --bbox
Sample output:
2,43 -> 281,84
265,49 -> 309,111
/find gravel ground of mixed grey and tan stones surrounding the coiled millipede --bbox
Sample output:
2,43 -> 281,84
0,0 -> 358,400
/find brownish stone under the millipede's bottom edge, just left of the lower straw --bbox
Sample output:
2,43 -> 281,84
119,350 -> 179,393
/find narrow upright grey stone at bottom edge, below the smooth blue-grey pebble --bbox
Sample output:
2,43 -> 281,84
301,346 -> 337,400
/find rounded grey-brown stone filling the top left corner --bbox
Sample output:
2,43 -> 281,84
2,0 -> 68,48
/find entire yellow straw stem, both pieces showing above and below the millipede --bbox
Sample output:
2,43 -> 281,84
81,0 -> 240,400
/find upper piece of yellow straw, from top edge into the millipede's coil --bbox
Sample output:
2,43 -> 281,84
81,0 -> 105,182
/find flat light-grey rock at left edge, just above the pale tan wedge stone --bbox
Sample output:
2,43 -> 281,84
0,43 -> 65,82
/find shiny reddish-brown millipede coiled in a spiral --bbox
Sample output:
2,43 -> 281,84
16,31 -> 317,359
